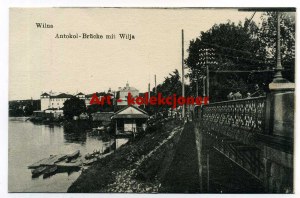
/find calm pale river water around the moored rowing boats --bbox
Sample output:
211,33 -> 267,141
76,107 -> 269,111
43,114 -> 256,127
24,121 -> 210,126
8,118 -> 108,192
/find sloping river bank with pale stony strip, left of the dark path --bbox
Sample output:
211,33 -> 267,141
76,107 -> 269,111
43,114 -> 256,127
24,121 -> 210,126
68,120 -> 182,193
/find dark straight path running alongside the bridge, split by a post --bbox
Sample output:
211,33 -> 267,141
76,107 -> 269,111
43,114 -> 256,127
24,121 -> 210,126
159,123 -> 263,193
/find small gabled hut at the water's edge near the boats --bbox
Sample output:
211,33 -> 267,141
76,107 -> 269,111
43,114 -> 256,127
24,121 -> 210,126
112,106 -> 149,135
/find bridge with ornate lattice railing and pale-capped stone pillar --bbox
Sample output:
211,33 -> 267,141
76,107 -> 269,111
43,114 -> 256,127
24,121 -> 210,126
194,82 -> 294,193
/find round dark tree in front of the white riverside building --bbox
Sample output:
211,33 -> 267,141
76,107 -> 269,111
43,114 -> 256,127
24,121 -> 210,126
63,96 -> 86,120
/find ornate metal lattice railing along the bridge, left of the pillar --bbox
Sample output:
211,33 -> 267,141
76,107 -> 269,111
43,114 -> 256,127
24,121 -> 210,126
195,97 -> 266,144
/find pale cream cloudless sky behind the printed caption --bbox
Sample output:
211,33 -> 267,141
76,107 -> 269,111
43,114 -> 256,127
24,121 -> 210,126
9,8 -> 261,100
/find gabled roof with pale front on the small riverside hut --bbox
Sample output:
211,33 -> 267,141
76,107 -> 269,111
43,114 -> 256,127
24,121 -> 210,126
112,106 -> 149,119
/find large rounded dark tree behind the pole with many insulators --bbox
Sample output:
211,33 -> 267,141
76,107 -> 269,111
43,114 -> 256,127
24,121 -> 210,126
186,20 -> 269,101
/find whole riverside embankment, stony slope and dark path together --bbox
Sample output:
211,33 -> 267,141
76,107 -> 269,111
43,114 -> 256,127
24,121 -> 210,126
68,121 -> 263,193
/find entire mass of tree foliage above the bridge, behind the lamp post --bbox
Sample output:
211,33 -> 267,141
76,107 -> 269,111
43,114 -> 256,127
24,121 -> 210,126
185,12 -> 295,101
